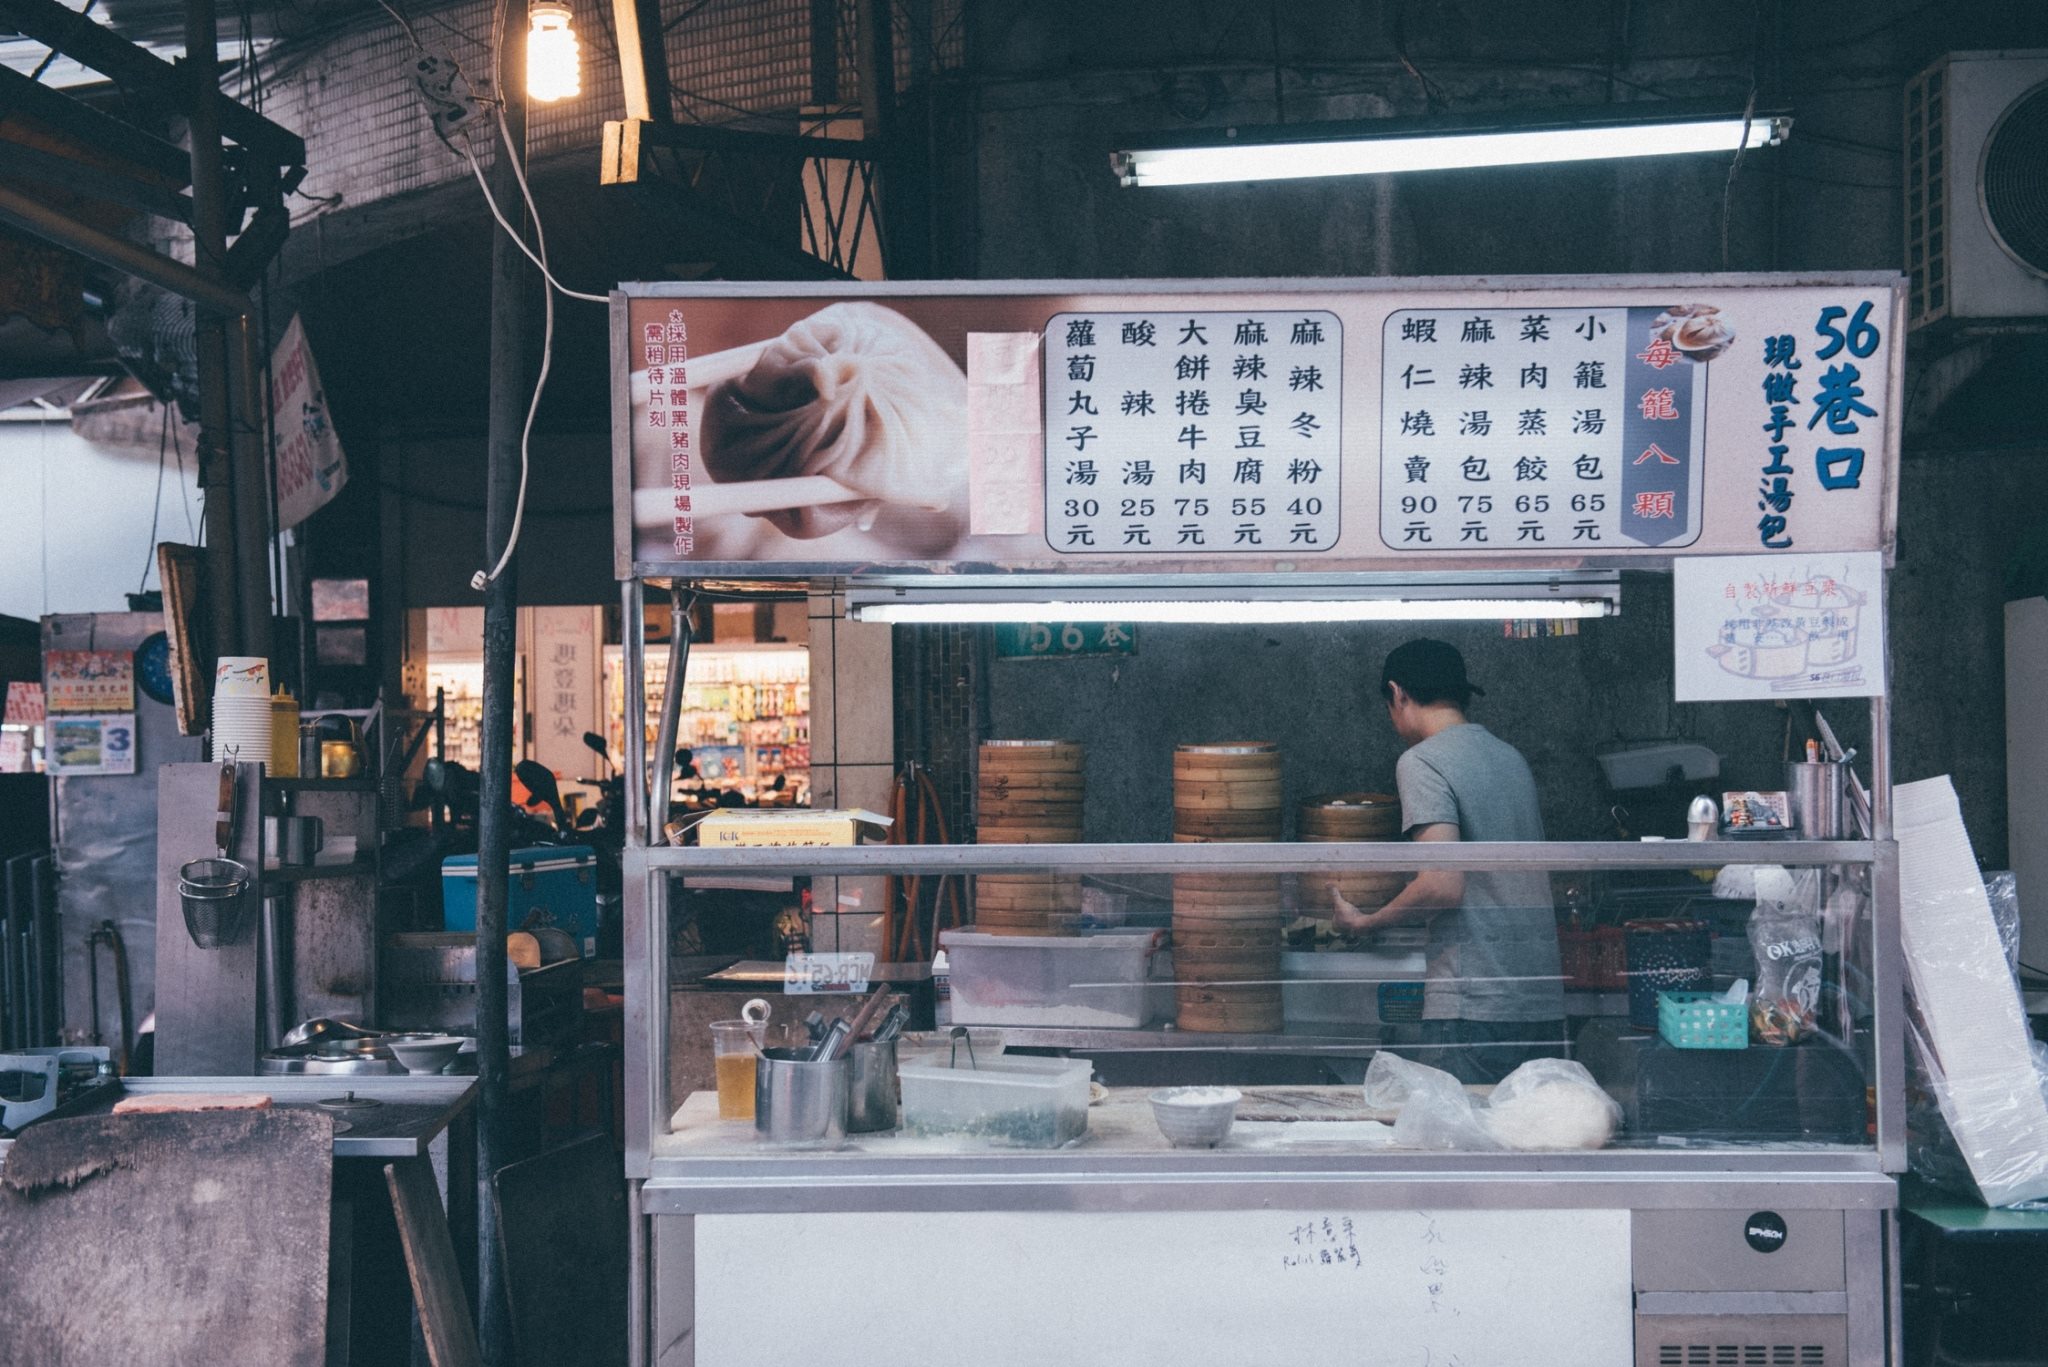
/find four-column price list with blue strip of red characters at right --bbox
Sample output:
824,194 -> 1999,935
1380,307 -> 1703,553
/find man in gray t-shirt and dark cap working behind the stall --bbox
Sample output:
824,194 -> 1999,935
1335,639 -> 1565,1082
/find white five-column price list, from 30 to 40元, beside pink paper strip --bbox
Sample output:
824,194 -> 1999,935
1044,309 -> 1343,555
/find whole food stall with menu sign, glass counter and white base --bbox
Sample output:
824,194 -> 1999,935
612,275 -> 1905,1367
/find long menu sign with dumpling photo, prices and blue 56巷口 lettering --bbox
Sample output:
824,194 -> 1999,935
612,275 -> 1901,574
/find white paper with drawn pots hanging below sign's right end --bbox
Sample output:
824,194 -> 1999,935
1671,551 -> 1884,703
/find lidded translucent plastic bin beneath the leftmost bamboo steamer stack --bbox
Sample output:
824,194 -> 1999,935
938,928 -> 1174,1029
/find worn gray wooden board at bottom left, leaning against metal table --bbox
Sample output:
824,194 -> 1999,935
0,1109 -> 334,1367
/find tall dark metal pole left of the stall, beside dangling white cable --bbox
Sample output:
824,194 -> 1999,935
477,0 -> 530,1367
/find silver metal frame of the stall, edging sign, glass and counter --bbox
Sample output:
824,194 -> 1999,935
612,275 -> 1907,1367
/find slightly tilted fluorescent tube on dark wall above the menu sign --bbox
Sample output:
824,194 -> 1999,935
1110,115 -> 1792,184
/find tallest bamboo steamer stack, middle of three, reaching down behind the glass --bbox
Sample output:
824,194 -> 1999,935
1174,742 -> 1286,1033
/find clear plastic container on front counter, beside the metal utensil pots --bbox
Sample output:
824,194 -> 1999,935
897,1049 -> 1096,1148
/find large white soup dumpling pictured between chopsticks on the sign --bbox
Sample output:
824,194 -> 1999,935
700,303 -> 969,539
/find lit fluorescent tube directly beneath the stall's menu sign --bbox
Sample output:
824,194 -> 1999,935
846,596 -> 1614,623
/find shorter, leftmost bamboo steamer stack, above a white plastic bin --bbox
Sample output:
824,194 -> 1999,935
975,740 -> 1085,935
